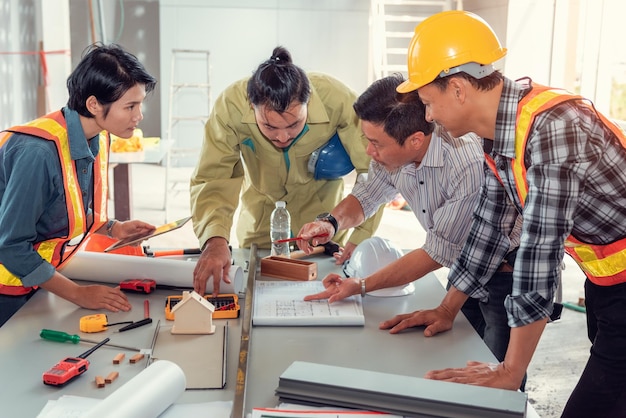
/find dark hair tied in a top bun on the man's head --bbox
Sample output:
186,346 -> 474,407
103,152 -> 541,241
248,46 -> 311,113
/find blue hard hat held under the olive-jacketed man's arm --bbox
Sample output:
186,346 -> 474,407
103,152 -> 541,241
308,133 -> 354,180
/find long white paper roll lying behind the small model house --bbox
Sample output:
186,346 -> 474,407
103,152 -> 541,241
60,251 -> 243,293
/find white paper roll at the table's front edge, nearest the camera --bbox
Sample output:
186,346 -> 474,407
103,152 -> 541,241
83,360 -> 187,418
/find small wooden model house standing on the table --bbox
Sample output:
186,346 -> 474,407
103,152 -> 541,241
172,291 -> 215,334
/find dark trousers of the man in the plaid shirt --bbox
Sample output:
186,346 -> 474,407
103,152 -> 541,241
562,280 -> 626,418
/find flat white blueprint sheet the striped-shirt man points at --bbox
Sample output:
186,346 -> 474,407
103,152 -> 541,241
252,280 -> 365,326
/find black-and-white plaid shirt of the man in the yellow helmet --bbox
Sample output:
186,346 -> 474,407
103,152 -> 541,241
449,79 -> 626,327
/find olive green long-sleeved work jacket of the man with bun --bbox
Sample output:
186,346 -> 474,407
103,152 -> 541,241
190,73 -> 383,248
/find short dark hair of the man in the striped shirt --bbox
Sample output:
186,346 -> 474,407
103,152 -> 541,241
353,74 -> 435,146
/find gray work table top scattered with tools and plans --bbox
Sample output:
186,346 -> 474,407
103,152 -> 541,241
0,250 -> 534,418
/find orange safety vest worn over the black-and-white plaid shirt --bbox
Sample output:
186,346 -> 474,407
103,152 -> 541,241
485,83 -> 626,286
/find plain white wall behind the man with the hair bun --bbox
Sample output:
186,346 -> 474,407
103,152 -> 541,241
160,0 -> 369,152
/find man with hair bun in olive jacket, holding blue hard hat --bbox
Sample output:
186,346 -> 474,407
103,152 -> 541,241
190,46 -> 383,294
